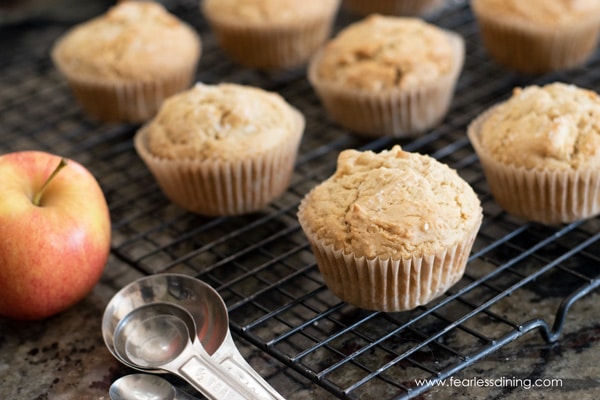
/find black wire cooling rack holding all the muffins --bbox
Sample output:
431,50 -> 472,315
0,1 -> 600,400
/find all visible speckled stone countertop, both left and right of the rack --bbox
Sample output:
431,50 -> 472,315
0,252 -> 600,400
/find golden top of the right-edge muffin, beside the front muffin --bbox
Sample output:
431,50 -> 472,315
478,82 -> 600,170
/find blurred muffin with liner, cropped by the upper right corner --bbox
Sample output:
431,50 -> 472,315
471,0 -> 600,74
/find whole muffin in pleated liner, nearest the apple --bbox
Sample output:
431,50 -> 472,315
134,83 -> 304,216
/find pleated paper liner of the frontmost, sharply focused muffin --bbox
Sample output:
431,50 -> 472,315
298,205 -> 481,312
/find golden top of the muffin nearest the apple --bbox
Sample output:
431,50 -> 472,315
145,83 -> 304,160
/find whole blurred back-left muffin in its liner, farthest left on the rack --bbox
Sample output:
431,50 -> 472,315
52,1 -> 201,123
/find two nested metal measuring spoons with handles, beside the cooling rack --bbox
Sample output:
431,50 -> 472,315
102,274 -> 284,400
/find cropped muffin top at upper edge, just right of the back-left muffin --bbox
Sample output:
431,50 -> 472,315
202,0 -> 340,26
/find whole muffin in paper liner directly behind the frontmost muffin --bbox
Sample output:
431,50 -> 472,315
308,14 -> 465,137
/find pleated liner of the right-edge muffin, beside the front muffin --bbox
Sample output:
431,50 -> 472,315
467,106 -> 600,225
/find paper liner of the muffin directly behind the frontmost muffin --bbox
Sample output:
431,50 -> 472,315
308,32 -> 465,137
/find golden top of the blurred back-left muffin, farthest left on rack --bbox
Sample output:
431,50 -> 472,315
52,1 -> 201,81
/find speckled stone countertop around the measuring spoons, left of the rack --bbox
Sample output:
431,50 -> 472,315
0,259 -> 335,400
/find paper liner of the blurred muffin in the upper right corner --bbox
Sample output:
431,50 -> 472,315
473,6 -> 600,74
